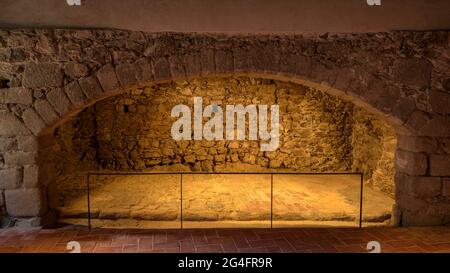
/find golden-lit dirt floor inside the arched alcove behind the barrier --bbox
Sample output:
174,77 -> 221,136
53,174 -> 394,228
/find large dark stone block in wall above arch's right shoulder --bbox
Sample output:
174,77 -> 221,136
393,58 -> 433,88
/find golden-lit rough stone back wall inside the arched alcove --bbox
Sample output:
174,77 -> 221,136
56,78 -> 360,172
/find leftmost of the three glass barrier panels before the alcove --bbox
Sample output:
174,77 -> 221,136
89,174 -> 181,229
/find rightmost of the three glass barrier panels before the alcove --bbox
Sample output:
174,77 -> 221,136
272,174 -> 361,228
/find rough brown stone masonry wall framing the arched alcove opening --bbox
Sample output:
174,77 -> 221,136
0,29 -> 450,226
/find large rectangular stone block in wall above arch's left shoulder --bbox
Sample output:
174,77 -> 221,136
23,63 -> 63,87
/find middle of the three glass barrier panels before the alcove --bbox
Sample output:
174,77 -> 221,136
182,174 -> 271,228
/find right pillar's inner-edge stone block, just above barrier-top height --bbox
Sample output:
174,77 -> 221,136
396,150 -> 428,175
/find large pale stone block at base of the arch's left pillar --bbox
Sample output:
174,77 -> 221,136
5,188 -> 47,217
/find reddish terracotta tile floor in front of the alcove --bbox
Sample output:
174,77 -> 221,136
0,227 -> 450,253
